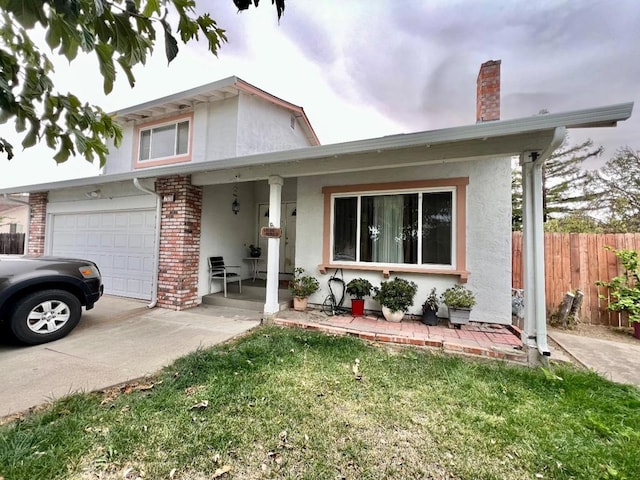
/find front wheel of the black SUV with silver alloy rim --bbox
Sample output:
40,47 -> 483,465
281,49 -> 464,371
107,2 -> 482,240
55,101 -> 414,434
9,290 -> 82,345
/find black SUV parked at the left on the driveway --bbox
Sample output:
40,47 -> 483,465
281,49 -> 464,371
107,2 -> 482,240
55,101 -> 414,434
0,256 -> 104,345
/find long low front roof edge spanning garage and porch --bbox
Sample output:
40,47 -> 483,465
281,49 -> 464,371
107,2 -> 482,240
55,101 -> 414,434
0,102 -> 633,194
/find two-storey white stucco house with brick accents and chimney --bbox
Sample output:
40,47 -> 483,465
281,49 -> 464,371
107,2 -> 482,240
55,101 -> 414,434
0,61 -> 633,356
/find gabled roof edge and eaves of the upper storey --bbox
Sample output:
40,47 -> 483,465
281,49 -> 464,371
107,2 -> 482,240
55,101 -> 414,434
112,76 -> 320,145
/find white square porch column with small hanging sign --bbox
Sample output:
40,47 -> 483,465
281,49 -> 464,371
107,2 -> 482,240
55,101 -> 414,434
264,175 -> 284,315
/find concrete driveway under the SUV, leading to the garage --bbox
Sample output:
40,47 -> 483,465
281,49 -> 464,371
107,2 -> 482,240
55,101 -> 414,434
0,296 -> 262,417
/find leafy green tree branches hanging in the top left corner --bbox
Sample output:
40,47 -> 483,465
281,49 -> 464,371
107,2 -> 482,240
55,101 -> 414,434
0,0 -> 284,166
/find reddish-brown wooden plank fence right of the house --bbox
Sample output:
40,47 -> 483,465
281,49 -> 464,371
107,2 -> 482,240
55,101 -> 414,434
511,232 -> 640,326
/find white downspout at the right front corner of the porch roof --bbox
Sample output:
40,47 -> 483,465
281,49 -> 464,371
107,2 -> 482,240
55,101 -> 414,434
521,127 -> 566,357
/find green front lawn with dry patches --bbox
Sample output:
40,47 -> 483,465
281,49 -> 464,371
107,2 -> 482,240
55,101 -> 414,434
0,327 -> 640,480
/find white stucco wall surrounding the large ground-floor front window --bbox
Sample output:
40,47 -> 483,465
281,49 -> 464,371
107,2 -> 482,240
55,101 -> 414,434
296,158 -> 511,324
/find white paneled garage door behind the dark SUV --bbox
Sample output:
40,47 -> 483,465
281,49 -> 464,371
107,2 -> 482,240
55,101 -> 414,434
51,210 -> 155,300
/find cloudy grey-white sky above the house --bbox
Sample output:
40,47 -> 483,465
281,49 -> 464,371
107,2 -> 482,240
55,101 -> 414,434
0,0 -> 640,188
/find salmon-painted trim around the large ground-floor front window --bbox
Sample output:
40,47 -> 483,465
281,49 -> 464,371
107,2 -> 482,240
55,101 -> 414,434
318,177 -> 469,283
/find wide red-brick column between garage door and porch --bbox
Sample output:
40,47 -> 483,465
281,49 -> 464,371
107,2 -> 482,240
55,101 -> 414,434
156,175 -> 202,310
